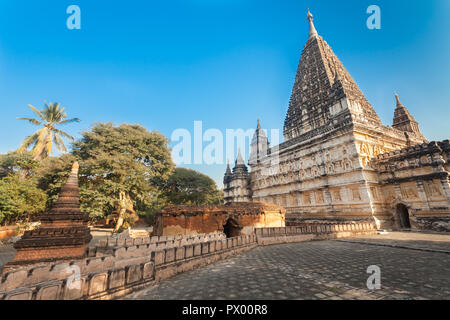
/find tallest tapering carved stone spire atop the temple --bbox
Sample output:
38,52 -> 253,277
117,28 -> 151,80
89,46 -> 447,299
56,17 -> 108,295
284,9 -> 382,140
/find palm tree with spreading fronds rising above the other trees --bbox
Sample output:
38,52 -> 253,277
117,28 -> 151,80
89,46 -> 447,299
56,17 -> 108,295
18,101 -> 80,161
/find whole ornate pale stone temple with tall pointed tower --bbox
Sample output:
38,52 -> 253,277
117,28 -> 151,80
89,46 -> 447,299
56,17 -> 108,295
224,12 -> 450,231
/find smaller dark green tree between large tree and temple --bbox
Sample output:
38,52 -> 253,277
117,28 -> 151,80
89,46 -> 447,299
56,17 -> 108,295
164,168 -> 223,205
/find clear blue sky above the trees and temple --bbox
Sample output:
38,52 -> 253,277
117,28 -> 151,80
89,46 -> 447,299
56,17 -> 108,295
0,0 -> 450,187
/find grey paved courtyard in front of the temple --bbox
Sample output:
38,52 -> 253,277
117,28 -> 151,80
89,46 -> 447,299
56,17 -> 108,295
125,233 -> 450,300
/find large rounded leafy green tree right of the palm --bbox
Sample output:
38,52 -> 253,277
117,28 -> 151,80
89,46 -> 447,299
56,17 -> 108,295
73,123 -> 174,231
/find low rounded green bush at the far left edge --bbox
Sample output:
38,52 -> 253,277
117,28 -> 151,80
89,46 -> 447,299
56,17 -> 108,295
0,175 -> 47,224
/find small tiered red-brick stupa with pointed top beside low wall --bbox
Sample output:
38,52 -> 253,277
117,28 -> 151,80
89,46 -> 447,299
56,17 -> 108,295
3,162 -> 92,272
